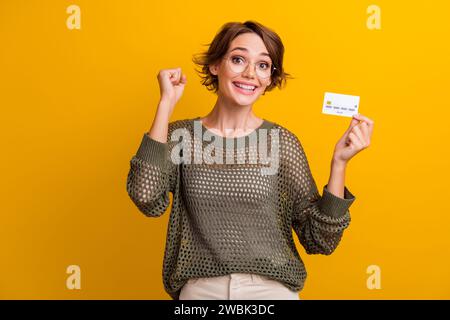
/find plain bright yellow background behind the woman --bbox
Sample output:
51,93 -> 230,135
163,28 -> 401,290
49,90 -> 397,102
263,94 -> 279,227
0,0 -> 450,299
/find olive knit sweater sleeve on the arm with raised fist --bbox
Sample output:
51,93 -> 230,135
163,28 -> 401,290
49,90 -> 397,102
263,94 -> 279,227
127,123 -> 179,217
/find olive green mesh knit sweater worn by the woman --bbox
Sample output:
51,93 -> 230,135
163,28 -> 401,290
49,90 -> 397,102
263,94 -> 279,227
127,117 -> 355,300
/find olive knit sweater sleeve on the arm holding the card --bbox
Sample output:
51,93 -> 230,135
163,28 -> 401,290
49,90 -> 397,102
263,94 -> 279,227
288,129 -> 355,255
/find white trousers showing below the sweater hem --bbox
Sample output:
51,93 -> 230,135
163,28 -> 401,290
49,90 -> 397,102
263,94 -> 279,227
180,273 -> 300,300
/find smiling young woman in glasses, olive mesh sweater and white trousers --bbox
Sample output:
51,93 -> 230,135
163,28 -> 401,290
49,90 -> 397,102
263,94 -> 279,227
127,21 -> 373,300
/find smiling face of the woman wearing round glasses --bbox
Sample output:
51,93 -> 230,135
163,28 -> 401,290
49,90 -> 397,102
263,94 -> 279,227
210,33 -> 272,106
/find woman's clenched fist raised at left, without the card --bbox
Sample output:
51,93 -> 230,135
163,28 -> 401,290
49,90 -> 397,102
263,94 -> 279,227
157,68 -> 187,116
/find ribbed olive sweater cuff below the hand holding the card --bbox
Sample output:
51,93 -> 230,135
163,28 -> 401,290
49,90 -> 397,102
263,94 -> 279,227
319,184 -> 355,218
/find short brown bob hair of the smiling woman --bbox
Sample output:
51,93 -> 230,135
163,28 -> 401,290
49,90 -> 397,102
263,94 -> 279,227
192,21 -> 293,95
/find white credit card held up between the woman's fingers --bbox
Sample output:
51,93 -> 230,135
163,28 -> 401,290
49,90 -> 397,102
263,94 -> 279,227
322,92 -> 359,117
